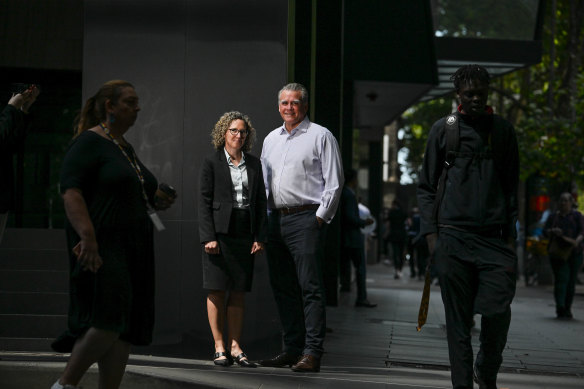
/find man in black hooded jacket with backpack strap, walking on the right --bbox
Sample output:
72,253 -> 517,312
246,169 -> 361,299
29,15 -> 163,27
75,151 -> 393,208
418,65 -> 519,389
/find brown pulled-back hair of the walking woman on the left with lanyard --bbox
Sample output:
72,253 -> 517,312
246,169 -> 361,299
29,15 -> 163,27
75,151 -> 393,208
74,80 -> 134,136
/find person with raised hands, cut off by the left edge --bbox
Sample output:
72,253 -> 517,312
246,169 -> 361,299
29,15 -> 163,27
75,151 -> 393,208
0,85 -> 40,243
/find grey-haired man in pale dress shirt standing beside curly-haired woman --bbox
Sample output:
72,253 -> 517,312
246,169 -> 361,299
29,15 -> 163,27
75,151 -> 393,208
260,83 -> 343,372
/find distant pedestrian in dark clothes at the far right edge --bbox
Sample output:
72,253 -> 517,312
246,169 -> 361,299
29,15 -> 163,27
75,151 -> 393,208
544,192 -> 584,319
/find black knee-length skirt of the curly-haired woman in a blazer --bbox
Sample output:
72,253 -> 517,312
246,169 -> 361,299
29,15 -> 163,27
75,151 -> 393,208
203,208 -> 254,292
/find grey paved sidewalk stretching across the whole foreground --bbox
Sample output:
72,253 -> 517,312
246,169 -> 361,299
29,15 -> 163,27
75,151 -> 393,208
0,264 -> 584,389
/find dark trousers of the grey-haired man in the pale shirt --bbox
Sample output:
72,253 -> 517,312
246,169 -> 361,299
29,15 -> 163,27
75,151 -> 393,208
267,211 -> 327,358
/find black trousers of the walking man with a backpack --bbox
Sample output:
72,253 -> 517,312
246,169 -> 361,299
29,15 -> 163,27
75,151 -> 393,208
434,228 -> 517,389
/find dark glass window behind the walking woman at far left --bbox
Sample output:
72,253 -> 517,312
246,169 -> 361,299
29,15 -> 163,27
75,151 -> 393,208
0,70 -> 81,228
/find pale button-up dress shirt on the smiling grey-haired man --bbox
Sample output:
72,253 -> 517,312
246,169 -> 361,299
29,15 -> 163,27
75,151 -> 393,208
261,117 -> 343,223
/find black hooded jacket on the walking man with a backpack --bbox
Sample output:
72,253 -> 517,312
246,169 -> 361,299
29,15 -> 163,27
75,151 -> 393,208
418,107 -> 519,239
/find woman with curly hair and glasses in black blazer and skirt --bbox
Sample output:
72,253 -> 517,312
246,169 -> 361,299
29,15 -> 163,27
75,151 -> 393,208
199,111 -> 267,367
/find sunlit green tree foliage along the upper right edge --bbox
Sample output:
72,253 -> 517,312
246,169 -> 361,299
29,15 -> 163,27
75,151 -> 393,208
504,0 -> 584,187
